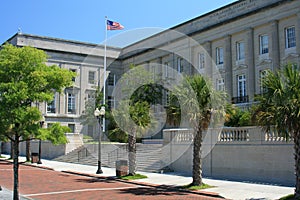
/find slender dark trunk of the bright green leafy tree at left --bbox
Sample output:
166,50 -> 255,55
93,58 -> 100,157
13,134 -> 20,200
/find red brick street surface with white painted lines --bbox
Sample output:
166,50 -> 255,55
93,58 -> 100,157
0,161 -> 223,200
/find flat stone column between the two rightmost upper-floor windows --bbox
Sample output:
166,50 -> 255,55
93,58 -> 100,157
270,20 -> 285,70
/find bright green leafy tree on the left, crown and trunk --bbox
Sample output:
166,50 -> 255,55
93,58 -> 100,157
0,44 -> 75,199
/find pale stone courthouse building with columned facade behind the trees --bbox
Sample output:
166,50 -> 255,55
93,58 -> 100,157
4,0 -> 300,135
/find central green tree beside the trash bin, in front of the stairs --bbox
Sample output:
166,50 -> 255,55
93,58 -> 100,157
112,65 -> 159,175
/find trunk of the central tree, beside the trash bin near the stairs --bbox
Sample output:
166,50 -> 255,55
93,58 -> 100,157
128,134 -> 136,176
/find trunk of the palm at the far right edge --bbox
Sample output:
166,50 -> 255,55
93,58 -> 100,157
294,131 -> 300,198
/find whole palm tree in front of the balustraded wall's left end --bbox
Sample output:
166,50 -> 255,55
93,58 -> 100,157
176,75 -> 226,186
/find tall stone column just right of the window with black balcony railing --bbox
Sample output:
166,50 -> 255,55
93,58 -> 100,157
245,28 -> 256,102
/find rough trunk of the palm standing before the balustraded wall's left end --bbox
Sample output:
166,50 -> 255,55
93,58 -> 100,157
192,126 -> 202,186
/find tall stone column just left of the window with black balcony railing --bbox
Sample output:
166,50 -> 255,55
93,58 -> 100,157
221,35 -> 233,99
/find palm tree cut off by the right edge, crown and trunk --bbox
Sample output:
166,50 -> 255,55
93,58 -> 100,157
254,65 -> 300,198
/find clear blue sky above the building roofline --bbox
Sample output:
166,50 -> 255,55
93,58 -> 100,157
0,0 -> 235,46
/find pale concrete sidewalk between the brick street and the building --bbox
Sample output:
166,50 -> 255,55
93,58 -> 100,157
0,157 -> 294,200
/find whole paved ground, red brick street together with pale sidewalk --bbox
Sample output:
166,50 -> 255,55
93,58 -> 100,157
0,157 -> 294,199
